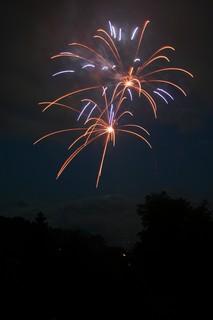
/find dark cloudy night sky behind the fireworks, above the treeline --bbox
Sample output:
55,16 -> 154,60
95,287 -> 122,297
0,0 -> 213,246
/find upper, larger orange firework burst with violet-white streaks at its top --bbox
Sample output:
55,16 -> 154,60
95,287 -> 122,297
46,20 -> 193,118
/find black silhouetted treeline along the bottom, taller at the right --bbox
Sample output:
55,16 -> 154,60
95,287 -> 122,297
0,191 -> 213,320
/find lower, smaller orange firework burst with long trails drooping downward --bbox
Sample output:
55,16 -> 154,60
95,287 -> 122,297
34,88 -> 152,188
